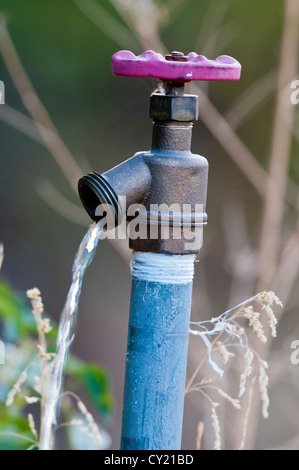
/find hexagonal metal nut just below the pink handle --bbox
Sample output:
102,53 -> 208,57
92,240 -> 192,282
150,93 -> 198,122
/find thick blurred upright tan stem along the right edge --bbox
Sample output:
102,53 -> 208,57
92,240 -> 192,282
257,0 -> 299,290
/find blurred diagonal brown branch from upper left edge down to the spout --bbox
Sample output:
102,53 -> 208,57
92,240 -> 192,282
0,14 -> 82,190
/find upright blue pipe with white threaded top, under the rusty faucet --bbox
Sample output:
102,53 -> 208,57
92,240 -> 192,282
121,252 -> 194,450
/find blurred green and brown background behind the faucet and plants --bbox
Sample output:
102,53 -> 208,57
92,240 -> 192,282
0,0 -> 299,449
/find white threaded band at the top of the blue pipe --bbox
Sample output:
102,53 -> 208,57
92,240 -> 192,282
131,251 -> 195,284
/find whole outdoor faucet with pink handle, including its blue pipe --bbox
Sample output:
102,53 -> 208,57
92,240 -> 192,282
79,51 -> 241,450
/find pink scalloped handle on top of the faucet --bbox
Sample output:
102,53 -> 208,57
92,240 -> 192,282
111,51 -> 241,82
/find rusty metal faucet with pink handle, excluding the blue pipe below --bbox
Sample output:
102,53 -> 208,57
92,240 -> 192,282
79,51 -> 240,254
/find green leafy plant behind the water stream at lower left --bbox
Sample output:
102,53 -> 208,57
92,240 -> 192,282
0,279 -> 114,450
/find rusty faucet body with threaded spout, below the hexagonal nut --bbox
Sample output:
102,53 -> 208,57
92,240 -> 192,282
79,122 -> 208,254
